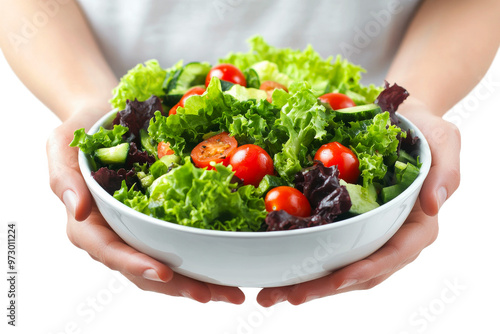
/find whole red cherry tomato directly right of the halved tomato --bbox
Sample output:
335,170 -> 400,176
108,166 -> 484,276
229,144 -> 274,187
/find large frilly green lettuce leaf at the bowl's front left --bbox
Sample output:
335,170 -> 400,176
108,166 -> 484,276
114,159 -> 266,231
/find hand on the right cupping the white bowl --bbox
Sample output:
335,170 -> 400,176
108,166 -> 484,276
257,101 -> 460,307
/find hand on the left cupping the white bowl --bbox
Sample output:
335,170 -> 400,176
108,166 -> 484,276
47,110 -> 245,304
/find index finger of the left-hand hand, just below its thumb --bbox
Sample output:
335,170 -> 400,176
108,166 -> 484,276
67,208 -> 173,282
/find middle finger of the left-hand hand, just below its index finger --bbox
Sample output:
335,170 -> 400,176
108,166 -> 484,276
124,273 -> 212,303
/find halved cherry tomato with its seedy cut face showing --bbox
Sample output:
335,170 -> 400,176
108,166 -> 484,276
191,132 -> 238,169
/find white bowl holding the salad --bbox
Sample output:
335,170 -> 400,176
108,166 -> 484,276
79,111 -> 431,287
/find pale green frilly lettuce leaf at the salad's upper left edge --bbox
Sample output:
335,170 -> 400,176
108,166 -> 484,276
109,59 -> 167,110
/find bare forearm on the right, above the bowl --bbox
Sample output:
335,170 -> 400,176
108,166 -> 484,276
387,0 -> 500,116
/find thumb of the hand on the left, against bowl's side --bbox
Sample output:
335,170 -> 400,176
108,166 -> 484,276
47,124 -> 92,221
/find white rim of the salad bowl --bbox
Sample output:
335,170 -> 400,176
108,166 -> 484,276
78,109 -> 432,238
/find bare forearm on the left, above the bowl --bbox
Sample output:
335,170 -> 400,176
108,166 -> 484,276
0,0 -> 117,120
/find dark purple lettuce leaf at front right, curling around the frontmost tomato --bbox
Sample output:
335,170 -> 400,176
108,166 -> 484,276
266,162 -> 352,231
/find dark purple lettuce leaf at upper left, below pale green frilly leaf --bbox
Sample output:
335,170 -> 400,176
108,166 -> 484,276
113,95 -> 163,145
